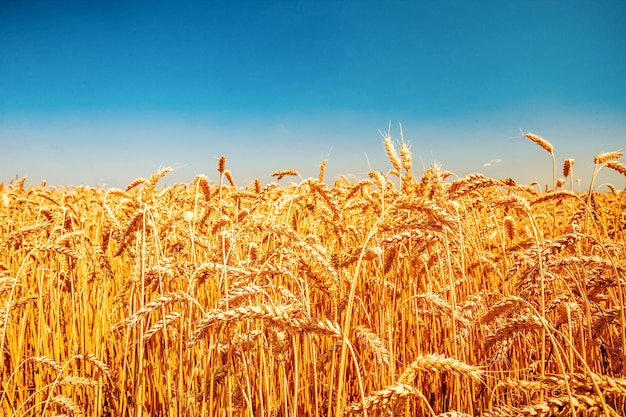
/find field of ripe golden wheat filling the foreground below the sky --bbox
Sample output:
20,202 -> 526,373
0,135 -> 626,417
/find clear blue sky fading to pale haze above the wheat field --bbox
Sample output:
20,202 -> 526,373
0,0 -> 626,188
